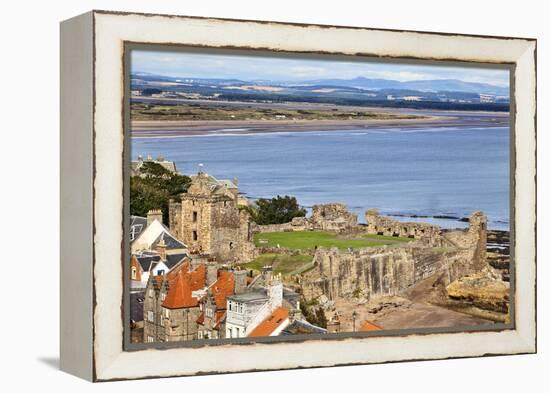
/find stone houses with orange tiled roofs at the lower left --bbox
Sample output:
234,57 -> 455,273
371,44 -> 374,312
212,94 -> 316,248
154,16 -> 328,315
143,258 -> 258,343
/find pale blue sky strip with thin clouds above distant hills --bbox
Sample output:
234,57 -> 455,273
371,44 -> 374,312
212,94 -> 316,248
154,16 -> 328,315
131,50 -> 509,87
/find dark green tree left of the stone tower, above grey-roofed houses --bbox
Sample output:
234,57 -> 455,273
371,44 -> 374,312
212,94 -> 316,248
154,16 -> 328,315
130,162 -> 191,223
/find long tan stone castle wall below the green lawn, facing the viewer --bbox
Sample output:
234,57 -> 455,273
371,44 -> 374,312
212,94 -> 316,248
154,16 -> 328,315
301,213 -> 487,300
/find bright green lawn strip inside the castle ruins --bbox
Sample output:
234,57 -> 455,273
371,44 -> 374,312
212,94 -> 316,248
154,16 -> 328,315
254,231 -> 411,250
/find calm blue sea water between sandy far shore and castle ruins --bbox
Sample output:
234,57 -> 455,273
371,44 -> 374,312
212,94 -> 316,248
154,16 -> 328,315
131,127 -> 510,230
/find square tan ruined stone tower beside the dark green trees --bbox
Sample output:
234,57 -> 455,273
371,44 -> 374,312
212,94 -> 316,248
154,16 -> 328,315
169,172 -> 256,262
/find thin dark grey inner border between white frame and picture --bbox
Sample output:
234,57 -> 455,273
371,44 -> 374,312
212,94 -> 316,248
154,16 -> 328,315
122,41 -> 515,351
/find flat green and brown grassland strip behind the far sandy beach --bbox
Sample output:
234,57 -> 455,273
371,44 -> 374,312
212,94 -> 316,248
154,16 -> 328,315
131,103 -> 423,121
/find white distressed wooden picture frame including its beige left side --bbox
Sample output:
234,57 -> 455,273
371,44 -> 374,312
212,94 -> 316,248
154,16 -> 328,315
60,11 -> 536,381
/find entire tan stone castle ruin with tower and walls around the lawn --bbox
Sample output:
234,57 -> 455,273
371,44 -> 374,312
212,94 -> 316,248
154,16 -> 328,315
169,172 -> 494,314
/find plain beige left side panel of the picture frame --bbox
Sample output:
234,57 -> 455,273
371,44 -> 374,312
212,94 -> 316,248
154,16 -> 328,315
59,12 -> 95,381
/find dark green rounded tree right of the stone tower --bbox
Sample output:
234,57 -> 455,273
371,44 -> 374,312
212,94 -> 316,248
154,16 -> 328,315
252,195 -> 306,225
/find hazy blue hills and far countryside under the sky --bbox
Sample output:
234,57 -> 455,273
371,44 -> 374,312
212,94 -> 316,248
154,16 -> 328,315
131,72 -> 509,111
